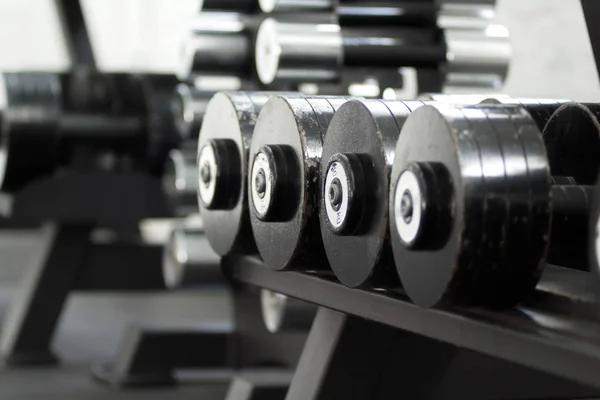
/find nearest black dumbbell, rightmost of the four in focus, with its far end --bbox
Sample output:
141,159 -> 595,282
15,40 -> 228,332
389,103 -> 600,308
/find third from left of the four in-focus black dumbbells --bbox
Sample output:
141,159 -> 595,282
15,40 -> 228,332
319,100 -> 424,287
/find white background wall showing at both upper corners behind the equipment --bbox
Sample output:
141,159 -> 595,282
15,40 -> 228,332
0,0 -> 600,101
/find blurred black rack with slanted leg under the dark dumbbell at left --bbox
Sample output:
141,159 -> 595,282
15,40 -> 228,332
0,171 -> 169,365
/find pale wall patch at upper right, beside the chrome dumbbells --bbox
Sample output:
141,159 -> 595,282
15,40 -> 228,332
496,0 -> 600,101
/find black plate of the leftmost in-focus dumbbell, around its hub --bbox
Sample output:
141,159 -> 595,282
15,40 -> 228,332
198,92 -> 266,255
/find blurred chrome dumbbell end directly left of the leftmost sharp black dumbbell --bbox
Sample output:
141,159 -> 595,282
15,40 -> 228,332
162,140 -> 198,216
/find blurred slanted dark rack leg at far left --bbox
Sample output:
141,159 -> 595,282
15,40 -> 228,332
0,224 -> 93,365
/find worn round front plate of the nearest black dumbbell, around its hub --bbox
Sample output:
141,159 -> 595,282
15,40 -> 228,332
390,105 -> 483,307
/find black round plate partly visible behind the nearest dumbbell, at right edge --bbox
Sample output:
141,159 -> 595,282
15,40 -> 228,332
543,103 -> 600,185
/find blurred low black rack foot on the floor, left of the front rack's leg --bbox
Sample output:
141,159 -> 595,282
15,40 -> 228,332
92,326 -> 231,387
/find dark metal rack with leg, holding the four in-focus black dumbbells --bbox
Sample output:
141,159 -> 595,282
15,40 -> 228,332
223,257 -> 600,400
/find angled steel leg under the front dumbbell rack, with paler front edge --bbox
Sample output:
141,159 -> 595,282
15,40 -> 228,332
286,308 -> 456,400
